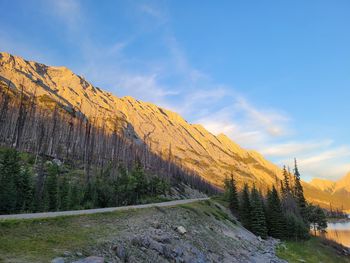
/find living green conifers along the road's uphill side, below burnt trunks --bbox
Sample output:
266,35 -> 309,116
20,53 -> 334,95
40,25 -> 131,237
0,148 -> 170,214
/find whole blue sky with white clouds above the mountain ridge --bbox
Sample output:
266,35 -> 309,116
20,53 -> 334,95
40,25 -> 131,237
0,0 -> 350,183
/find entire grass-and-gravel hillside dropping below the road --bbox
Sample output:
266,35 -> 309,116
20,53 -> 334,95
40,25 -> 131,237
0,201 -> 288,262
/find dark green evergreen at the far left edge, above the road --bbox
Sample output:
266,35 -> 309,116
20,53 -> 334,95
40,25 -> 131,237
0,149 -> 20,213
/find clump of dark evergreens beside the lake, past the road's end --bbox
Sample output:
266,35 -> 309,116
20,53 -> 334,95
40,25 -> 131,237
225,160 -> 327,240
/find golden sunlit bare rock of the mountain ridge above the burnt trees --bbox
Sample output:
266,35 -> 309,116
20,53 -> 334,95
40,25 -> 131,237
0,53 -> 350,209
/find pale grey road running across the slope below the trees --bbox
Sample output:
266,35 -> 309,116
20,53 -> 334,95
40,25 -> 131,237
0,198 -> 209,220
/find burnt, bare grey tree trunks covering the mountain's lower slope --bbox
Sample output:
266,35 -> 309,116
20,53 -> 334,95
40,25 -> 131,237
0,81 -> 219,214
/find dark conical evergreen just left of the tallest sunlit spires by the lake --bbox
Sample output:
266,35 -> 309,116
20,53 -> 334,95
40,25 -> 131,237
266,186 -> 286,239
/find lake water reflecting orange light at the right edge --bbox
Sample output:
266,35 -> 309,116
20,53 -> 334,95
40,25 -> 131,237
325,221 -> 350,248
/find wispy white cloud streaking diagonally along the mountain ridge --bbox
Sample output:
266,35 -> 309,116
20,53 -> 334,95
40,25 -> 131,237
0,0 -> 350,182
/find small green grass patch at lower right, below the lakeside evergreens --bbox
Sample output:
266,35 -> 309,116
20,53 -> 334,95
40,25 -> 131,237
277,237 -> 350,263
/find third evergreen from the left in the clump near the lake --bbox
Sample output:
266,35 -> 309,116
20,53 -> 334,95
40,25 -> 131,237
250,186 -> 267,238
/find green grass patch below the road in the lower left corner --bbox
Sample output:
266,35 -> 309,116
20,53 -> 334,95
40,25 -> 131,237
0,210 -> 139,262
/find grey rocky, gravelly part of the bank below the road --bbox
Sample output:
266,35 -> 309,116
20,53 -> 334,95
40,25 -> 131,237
52,201 -> 285,263
